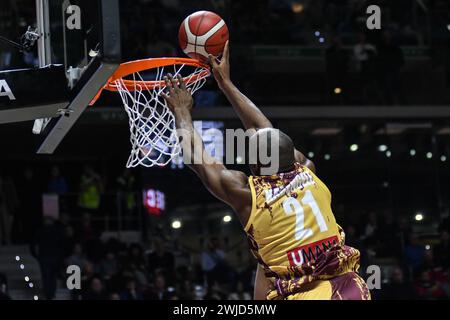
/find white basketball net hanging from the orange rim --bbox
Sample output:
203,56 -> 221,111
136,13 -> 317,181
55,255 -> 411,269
113,65 -> 209,168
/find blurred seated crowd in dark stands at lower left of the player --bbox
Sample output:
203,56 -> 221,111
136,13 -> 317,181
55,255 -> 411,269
31,224 -> 254,300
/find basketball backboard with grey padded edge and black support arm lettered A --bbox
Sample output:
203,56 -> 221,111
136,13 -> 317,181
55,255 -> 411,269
0,0 -> 121,154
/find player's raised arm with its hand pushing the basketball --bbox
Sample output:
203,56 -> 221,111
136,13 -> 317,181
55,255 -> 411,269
209,42 -> 273,130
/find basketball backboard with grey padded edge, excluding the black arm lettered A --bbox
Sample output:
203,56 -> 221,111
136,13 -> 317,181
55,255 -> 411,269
35,0 -> 121,154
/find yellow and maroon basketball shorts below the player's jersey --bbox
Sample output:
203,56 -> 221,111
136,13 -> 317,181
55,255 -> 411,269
287,272 -> 371,300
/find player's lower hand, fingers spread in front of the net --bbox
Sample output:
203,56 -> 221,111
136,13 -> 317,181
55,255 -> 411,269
161,73 -> 194,113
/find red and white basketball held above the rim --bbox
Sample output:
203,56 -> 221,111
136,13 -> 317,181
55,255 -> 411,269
178,11 -> 229,62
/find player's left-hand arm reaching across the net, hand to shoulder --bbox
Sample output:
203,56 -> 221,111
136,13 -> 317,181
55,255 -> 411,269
162,75 -> 252,225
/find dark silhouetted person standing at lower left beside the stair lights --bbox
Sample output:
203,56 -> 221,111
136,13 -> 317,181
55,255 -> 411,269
31,217 -> 64,300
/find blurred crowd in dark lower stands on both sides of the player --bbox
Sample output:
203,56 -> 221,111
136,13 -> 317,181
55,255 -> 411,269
0,166 -> 450,300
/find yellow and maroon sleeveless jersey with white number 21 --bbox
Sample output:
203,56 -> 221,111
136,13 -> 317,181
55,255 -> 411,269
245,164 -> 360,299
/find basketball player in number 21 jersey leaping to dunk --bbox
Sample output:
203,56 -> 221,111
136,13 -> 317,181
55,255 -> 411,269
163,44 -> 370,300
